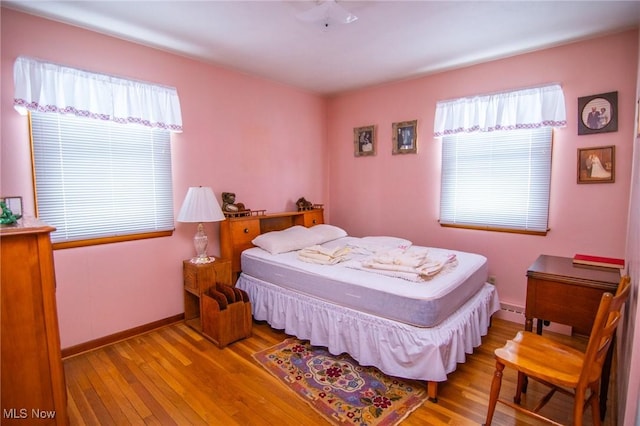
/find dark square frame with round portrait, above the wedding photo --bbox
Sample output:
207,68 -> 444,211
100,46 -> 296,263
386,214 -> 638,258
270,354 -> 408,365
578,92 -> 618,135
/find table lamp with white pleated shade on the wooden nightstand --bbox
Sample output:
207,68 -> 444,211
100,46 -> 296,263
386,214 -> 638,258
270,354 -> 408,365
178,186 -> 225,264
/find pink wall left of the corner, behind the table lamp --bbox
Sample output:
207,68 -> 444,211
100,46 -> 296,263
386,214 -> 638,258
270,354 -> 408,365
0,8 -> 328,347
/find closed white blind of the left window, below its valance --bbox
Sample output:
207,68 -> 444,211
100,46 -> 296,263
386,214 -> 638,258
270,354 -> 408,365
31,112 -> 174,243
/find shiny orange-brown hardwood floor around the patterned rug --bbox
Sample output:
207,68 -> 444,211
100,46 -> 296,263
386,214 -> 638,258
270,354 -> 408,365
64,319 -> 616,426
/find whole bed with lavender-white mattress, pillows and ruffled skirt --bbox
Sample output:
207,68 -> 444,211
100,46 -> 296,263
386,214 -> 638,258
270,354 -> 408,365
221,211 -> 499,401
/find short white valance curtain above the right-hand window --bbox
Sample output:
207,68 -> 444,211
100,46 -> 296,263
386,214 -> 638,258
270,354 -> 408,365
434,84 -> 567,137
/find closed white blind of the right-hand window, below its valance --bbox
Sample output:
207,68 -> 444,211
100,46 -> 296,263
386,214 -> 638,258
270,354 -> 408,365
440,127 -> 552,234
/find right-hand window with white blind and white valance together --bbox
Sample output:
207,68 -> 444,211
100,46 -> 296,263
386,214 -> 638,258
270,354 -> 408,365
434,83 -> 567,235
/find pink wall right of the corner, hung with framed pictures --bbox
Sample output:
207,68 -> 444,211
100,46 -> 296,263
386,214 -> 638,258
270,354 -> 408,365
328,31 -> 638,312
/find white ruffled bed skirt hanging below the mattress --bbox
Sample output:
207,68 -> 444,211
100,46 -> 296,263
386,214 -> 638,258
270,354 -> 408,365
236,274 -> 500,382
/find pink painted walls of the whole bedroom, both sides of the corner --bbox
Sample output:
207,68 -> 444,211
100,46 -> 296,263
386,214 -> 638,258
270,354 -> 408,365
0,8 -> 640,424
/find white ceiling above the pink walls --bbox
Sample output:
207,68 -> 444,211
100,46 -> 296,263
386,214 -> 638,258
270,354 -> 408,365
2,0 -> 640,95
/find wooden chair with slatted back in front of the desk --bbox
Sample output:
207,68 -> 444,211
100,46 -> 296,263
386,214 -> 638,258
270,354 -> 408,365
485,276 -> 631,426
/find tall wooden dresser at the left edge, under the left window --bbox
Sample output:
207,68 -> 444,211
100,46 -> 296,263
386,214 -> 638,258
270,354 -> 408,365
0,219 -> 69,425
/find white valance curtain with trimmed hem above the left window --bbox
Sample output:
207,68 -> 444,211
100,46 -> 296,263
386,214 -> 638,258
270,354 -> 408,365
13,56 -> 182,132
